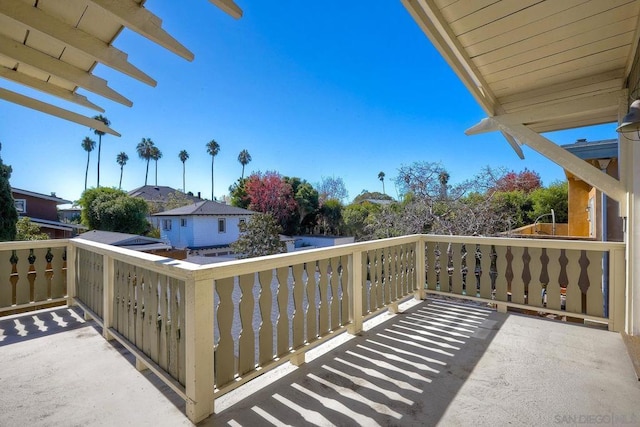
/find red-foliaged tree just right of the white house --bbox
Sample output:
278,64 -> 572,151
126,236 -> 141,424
245,171 -> 298,226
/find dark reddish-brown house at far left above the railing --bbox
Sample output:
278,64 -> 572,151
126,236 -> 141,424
11,188 -> 86,239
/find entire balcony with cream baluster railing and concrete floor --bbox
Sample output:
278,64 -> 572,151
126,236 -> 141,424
0,235 -> 640,425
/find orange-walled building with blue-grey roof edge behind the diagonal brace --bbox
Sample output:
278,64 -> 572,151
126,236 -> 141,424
562,139 -> 624,242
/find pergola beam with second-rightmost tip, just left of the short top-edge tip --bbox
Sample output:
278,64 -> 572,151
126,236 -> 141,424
91,0 -> 194,61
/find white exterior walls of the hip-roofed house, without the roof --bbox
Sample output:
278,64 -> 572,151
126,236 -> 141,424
155,215 -> 249,248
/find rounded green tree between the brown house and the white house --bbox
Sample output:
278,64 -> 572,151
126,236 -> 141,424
78,187 -> 150,234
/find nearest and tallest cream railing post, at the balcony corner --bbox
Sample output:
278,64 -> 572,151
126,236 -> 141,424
184,276 -> 214,423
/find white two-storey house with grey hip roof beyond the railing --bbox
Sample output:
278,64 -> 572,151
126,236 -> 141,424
153,200 -> 253,253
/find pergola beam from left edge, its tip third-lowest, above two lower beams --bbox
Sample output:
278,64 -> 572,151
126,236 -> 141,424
0,35 -> 133,107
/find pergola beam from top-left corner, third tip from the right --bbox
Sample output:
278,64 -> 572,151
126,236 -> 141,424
0,0 -> 157,86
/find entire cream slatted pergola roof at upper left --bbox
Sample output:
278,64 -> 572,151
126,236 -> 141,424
0,0 -> 242,136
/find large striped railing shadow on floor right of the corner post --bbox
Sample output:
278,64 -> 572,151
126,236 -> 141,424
210,300 -> 506,426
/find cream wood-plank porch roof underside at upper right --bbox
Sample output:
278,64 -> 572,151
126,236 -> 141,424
402,0 -> 640,135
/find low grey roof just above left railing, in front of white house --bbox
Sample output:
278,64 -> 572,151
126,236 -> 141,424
76,230 -> 186,259
